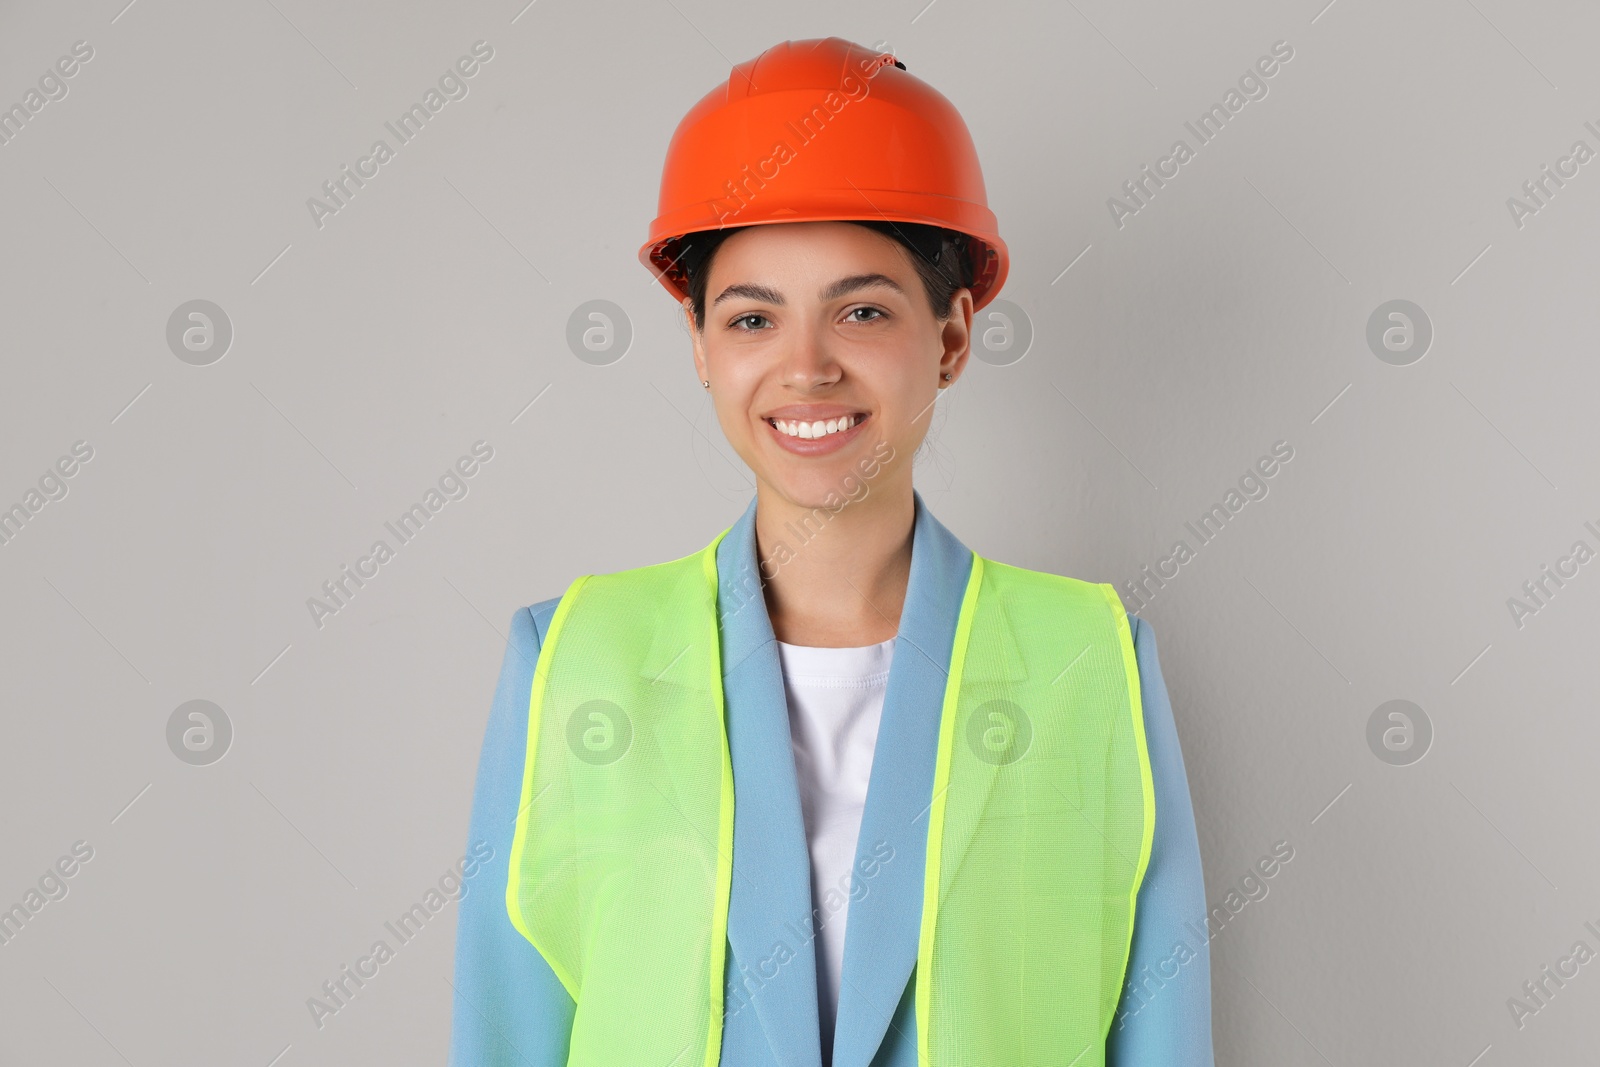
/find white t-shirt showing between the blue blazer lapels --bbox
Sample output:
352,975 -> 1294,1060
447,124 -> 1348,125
778,638 -> 894,1062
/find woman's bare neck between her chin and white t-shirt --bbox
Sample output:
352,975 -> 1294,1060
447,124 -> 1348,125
755,485 -> 917,648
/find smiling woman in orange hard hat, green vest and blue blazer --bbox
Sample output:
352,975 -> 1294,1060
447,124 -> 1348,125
451,37 -> 1211,1067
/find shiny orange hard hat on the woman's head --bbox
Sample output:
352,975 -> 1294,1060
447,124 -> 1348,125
638,37 -> 1008,307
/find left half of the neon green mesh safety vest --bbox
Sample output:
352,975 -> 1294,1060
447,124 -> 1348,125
506,531 -> 733,1067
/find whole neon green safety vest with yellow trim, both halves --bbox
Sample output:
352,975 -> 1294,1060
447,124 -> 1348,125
506,528 -> 1155,1067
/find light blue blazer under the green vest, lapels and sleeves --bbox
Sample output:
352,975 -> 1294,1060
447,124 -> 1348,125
450,491 -> 1213,1067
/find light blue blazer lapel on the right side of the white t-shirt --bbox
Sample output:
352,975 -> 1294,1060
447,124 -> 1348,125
832,490 -> 973,1067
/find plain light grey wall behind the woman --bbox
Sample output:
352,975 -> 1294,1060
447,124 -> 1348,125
0,0 -> 1600,1067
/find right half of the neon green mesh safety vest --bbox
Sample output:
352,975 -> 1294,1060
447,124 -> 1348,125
917,557 -> 1155,1067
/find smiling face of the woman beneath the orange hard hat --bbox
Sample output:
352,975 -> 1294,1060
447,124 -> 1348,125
685,222 -> 973,509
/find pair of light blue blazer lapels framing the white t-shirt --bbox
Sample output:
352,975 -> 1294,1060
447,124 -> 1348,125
717,490 -> 973,1067
